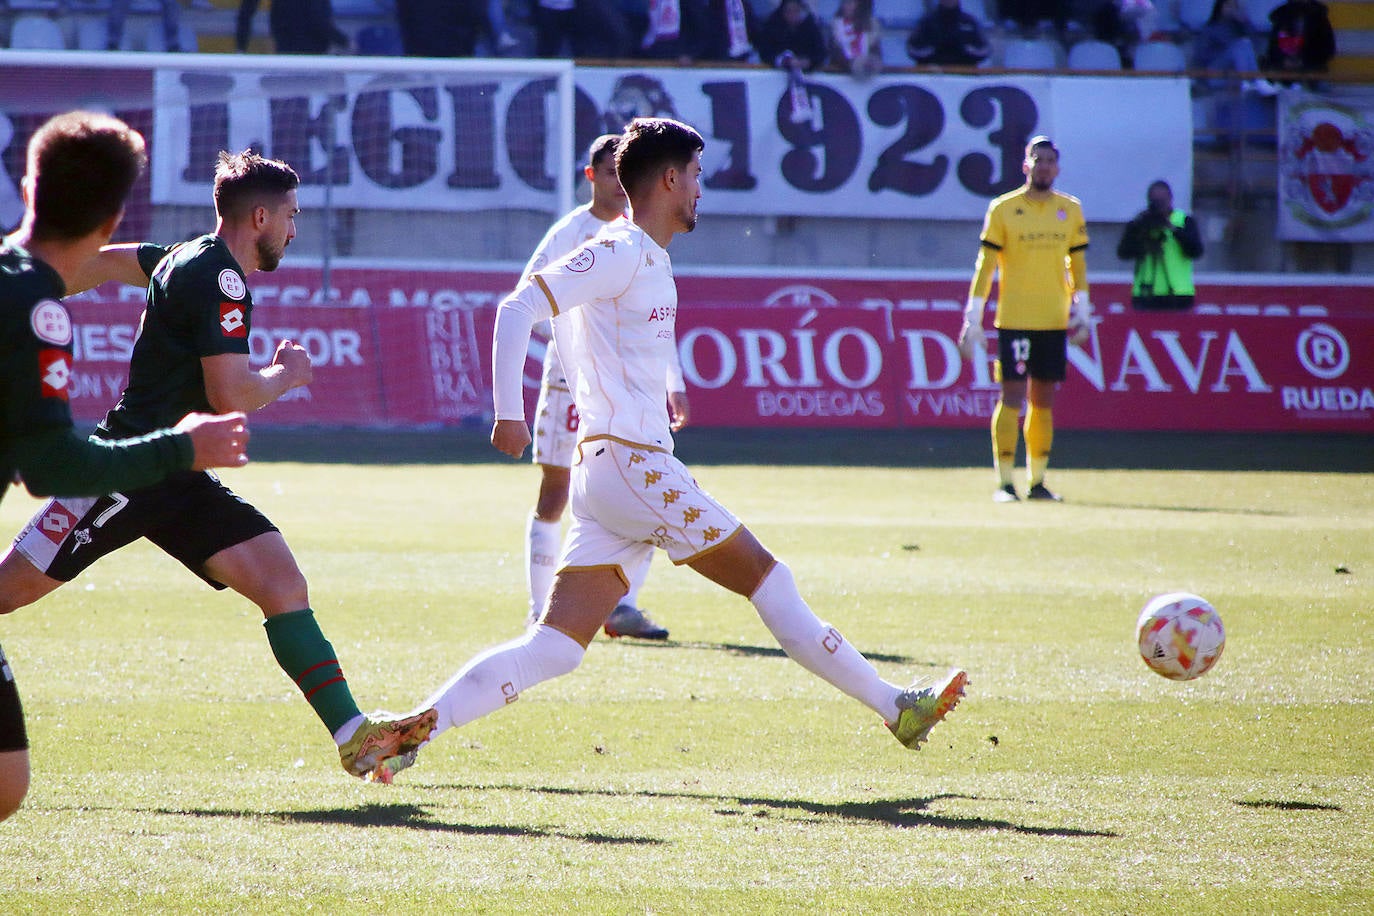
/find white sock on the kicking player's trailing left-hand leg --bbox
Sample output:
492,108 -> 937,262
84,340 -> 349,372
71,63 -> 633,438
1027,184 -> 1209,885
420,626 -> 587,740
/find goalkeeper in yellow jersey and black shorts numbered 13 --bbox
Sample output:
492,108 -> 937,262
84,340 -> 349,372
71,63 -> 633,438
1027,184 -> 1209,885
959,136 -> 1092,503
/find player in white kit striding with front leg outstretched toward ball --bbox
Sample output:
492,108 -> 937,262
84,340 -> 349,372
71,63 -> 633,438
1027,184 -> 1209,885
374,118 -> 967,781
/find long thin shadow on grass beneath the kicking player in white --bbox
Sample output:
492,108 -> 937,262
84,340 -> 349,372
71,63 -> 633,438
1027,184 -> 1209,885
420,786 -> 1117,839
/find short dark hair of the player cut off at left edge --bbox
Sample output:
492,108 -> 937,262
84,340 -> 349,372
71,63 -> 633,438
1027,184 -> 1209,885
25,111 -> 148,240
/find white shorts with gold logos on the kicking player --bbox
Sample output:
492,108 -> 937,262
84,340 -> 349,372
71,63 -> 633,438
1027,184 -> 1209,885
558,439 -> 741,570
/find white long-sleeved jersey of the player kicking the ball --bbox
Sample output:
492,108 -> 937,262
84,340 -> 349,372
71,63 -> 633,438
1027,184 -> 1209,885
492,218 -> 677,452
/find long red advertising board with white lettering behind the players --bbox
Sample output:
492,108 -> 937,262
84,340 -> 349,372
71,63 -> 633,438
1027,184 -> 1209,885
61,268 -> 1374,433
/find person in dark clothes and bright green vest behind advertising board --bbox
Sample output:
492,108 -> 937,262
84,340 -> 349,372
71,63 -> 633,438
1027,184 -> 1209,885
1117,180 -> 1202,312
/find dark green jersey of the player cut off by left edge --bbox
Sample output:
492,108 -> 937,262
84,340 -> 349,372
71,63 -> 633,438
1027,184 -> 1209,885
0,243 -> 192,505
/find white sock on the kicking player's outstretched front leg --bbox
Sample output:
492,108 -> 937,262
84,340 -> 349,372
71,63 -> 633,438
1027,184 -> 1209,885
749,563 -> 901,722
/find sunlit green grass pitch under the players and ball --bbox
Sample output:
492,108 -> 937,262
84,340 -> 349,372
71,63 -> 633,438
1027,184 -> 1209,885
0,439 -> 1374,915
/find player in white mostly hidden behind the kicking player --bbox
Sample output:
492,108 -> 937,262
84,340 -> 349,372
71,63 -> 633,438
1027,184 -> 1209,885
521,133 -> 690,640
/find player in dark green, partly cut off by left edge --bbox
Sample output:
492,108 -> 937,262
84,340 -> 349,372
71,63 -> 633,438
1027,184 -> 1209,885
0,111 -> 249,821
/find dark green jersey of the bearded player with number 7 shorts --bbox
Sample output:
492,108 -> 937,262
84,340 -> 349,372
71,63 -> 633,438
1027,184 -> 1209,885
98,235 -> 253,437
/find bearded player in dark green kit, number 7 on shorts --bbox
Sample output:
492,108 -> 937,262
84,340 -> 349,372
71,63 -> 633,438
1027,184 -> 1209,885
0,146 -> 436,777
